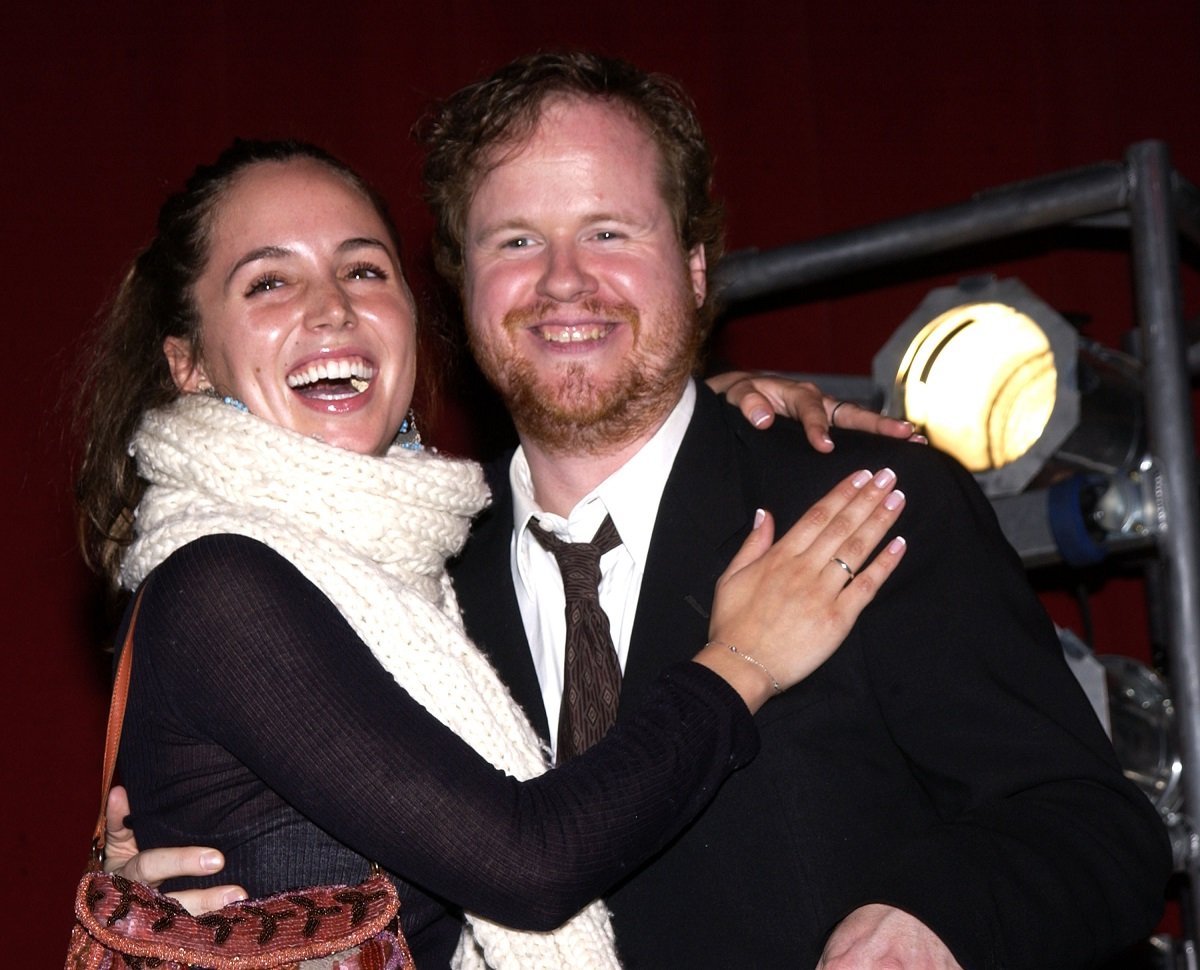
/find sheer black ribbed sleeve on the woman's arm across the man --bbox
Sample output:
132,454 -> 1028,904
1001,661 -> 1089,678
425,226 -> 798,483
126,535 -> 757,929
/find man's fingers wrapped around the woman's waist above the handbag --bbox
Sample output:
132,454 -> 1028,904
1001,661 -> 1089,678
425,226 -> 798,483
104,785 -> 246,916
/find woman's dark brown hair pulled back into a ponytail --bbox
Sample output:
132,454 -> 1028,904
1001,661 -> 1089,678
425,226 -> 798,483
76,138 -> 400,587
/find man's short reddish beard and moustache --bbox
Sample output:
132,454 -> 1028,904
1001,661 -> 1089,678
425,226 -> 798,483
472,293 -> 701,455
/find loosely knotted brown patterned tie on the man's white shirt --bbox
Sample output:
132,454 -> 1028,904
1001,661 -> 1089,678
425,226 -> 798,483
529,515 -> 620,765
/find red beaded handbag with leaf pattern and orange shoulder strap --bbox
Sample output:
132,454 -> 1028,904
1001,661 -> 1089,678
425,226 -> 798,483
66,594 -> 414,970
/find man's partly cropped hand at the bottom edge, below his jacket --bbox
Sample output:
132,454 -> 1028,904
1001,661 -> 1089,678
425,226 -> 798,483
817,903 -> 962,970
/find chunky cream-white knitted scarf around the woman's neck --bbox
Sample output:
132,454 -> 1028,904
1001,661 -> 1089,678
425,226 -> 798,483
121,394 -> 619,970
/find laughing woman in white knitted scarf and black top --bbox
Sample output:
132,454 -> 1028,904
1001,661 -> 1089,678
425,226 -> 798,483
80,143 -> 904,970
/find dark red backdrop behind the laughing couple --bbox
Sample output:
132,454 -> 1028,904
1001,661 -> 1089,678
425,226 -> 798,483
0,0 -> 1200,966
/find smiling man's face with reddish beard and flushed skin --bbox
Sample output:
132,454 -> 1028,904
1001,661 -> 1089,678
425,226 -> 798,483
463,97 -> 704,453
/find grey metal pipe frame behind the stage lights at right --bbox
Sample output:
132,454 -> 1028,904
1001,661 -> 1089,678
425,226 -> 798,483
716,142 -> 1200,940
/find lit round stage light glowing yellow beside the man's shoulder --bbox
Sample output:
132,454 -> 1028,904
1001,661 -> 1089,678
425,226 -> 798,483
874,276 -> 1142,496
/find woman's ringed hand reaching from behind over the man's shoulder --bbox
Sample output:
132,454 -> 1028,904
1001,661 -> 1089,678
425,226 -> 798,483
707,371 -> 925,451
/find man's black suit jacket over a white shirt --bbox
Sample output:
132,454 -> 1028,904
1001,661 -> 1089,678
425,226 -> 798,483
454,388 -> 1170,970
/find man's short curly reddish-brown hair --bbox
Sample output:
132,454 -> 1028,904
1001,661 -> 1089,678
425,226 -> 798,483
415,50 -> 725,319
